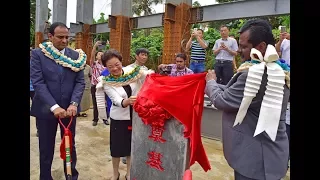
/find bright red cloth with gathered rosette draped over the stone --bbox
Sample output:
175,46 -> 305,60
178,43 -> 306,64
133,73 -> 211,171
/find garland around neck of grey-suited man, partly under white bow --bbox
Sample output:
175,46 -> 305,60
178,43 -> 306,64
237,59 -> 290,89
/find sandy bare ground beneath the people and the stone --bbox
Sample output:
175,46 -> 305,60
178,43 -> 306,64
30,107 -> 290,180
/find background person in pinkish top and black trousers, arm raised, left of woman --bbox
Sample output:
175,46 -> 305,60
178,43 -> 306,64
90,41 -> 109,126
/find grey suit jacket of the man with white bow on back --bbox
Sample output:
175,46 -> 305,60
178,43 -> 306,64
206,70 -> 290,180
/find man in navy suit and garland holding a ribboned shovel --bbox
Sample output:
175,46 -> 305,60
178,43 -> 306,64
30,22 -> 85,180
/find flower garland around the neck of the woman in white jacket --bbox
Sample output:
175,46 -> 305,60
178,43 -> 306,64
103,66 -> 142,87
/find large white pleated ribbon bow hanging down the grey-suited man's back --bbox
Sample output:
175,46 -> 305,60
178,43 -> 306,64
233,45 -> 285,141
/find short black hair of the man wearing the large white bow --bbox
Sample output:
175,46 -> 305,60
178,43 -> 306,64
239,19 -> 276,47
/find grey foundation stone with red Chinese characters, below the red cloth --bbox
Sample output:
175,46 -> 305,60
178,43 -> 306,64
130,112 -> 189,180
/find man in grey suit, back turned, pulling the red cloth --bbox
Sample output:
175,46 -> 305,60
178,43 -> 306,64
205,19 -> 290,180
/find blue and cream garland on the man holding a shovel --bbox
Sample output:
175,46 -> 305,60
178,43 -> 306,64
39,42 -> 87,72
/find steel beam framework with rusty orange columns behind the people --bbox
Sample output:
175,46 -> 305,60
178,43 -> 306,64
35,0 -> 290,65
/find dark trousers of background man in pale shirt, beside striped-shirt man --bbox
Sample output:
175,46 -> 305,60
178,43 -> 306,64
214,60 -> 234,85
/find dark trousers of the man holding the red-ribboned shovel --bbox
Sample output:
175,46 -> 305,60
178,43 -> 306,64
37,117 -> 79,180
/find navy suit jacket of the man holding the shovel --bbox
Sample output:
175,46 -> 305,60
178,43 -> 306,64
30,48 -> 85,118
